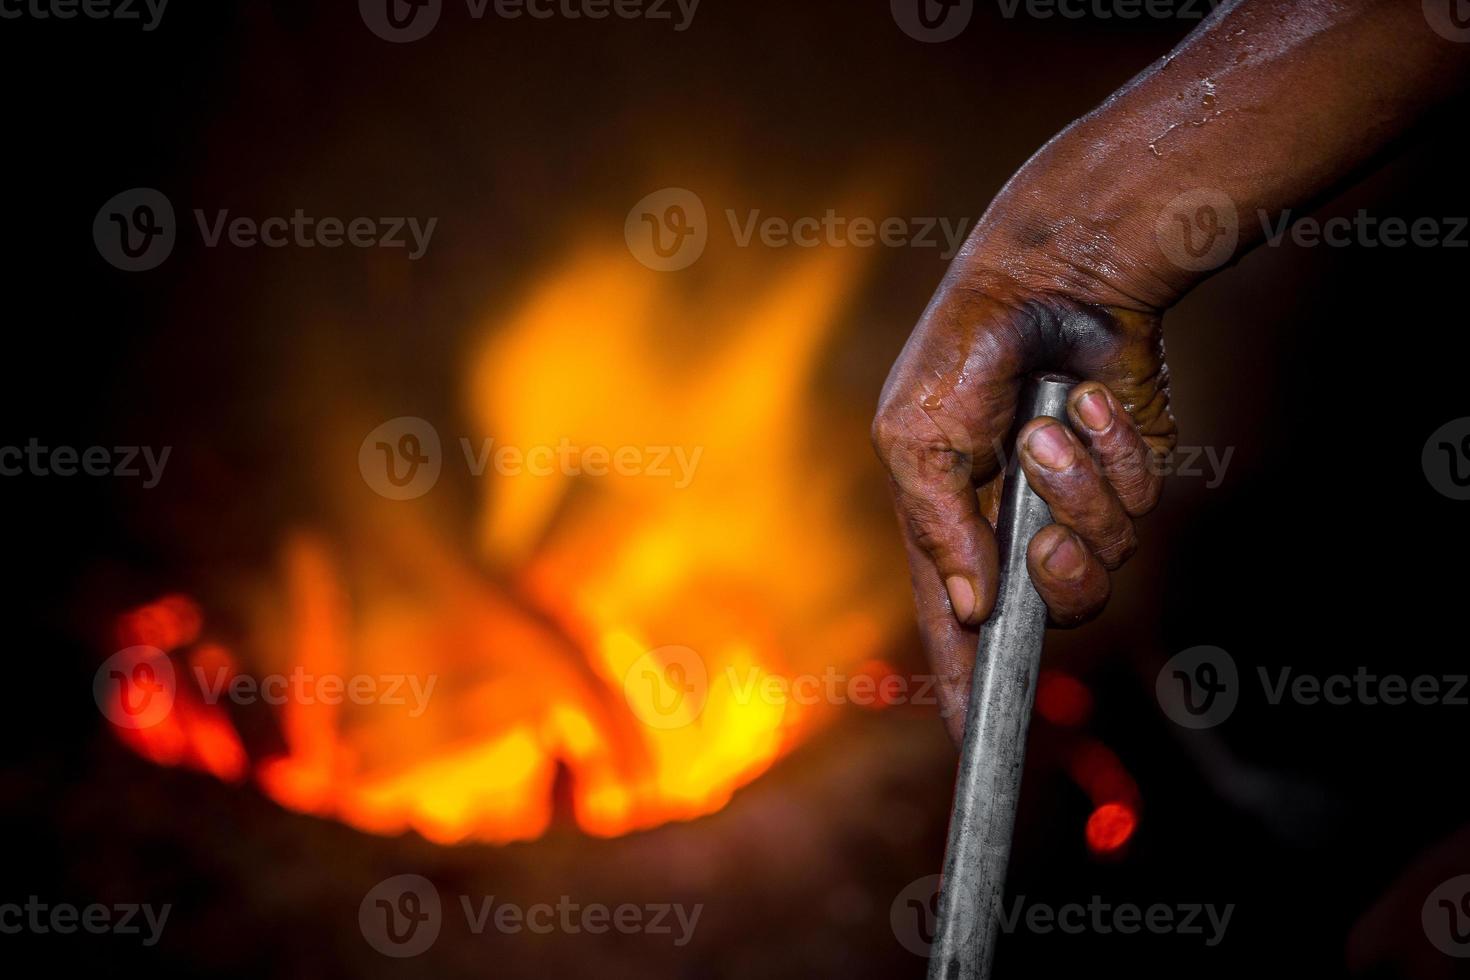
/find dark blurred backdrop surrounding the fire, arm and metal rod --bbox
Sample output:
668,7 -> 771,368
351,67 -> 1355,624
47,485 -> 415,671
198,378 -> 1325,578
0,0 -> 1470,977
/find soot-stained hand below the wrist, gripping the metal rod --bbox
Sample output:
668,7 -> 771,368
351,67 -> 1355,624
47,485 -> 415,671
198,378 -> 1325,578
873,267 -> 1175,733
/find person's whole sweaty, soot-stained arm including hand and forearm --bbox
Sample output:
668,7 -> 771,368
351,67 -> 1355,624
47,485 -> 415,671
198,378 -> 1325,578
873,0 -> 1470,738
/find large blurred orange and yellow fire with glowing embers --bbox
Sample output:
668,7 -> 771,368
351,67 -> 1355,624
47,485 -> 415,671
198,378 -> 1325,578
106,248 -> 907,842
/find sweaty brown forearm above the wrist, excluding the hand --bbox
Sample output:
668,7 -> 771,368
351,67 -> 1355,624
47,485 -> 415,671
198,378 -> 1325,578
961,0 -> 1470,310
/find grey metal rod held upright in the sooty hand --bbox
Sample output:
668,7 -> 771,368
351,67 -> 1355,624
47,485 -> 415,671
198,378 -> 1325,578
929,375 -> 1075,980
